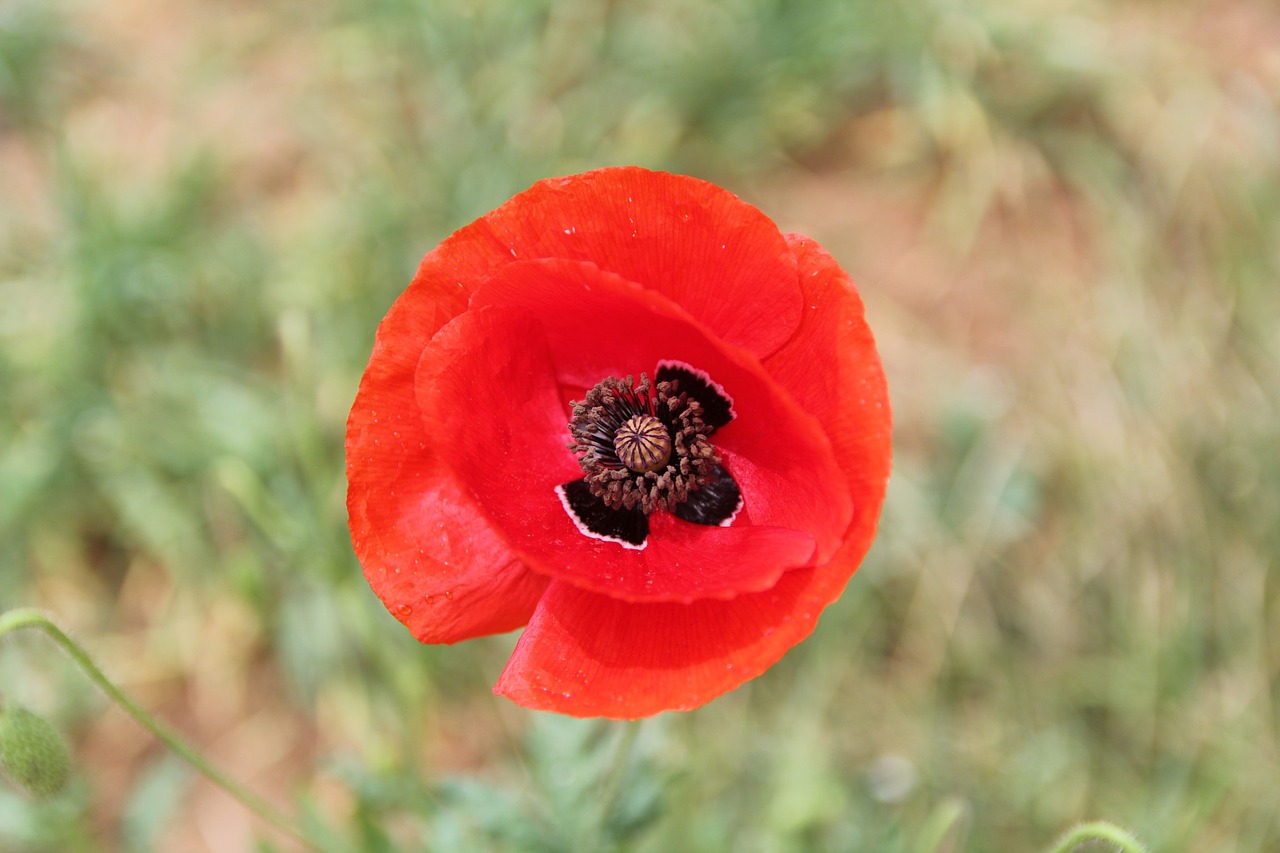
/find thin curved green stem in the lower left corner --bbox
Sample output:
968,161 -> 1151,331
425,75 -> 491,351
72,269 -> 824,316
0,607 -> 310,847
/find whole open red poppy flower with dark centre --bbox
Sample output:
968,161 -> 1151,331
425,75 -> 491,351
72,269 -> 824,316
347,168 -> 890,717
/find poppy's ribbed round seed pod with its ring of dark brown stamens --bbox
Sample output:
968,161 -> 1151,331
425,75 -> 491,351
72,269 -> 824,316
568,374 -> 721,514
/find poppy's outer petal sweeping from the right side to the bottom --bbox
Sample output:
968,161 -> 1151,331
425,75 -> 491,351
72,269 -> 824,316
494,229 -> 891,719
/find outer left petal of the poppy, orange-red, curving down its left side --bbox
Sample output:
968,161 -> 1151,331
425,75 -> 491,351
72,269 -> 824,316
347,234 -> 547,643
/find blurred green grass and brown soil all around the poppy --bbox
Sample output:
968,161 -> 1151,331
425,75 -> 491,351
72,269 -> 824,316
0,0 -> 1280,853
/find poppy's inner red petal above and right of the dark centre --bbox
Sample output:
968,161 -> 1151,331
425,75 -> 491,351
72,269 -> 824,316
471,260 -> 851,558
